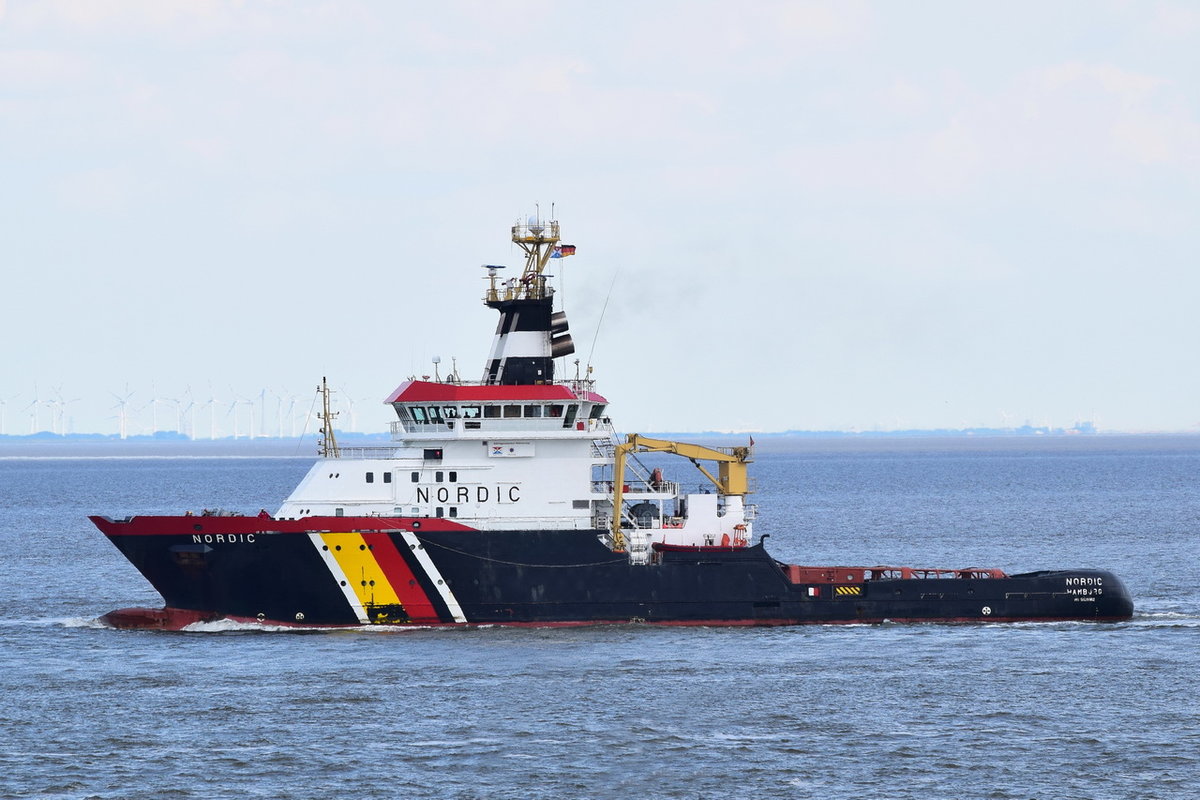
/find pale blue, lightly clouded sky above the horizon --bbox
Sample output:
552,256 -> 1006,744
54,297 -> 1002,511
0,0 -> 1200,437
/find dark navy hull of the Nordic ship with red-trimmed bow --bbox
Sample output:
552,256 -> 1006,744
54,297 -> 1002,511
91,517 -> 1133,628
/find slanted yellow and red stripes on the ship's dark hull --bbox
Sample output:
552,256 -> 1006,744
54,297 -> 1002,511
313,533 -> 442,622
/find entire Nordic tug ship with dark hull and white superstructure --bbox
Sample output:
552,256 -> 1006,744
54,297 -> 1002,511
90,215 -> 1133,630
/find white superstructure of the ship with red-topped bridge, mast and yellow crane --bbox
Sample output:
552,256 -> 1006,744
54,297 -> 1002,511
276,219 -> 754,561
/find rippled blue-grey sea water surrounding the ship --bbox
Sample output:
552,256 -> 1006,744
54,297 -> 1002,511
0,437 -> 1200,800
